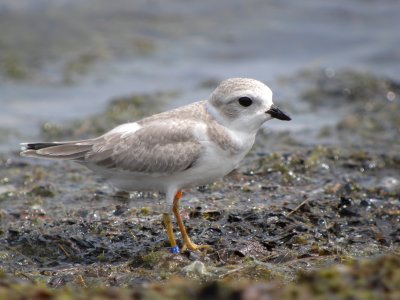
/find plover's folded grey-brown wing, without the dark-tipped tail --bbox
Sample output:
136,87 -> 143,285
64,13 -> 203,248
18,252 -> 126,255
85,121 -> 203,174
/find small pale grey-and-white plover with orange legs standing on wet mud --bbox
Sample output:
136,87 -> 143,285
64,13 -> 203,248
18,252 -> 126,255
21,78 -> 291,253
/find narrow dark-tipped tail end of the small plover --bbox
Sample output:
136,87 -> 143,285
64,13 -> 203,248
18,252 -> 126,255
20,141 -> 93,160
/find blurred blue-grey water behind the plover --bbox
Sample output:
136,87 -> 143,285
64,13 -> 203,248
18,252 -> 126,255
0,0 -> 400,150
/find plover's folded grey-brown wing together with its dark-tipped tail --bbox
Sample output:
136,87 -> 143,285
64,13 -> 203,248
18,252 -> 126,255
21,121 -> 203,174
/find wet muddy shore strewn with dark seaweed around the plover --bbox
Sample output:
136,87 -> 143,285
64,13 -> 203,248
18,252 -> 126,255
0,70 -> 400,299
